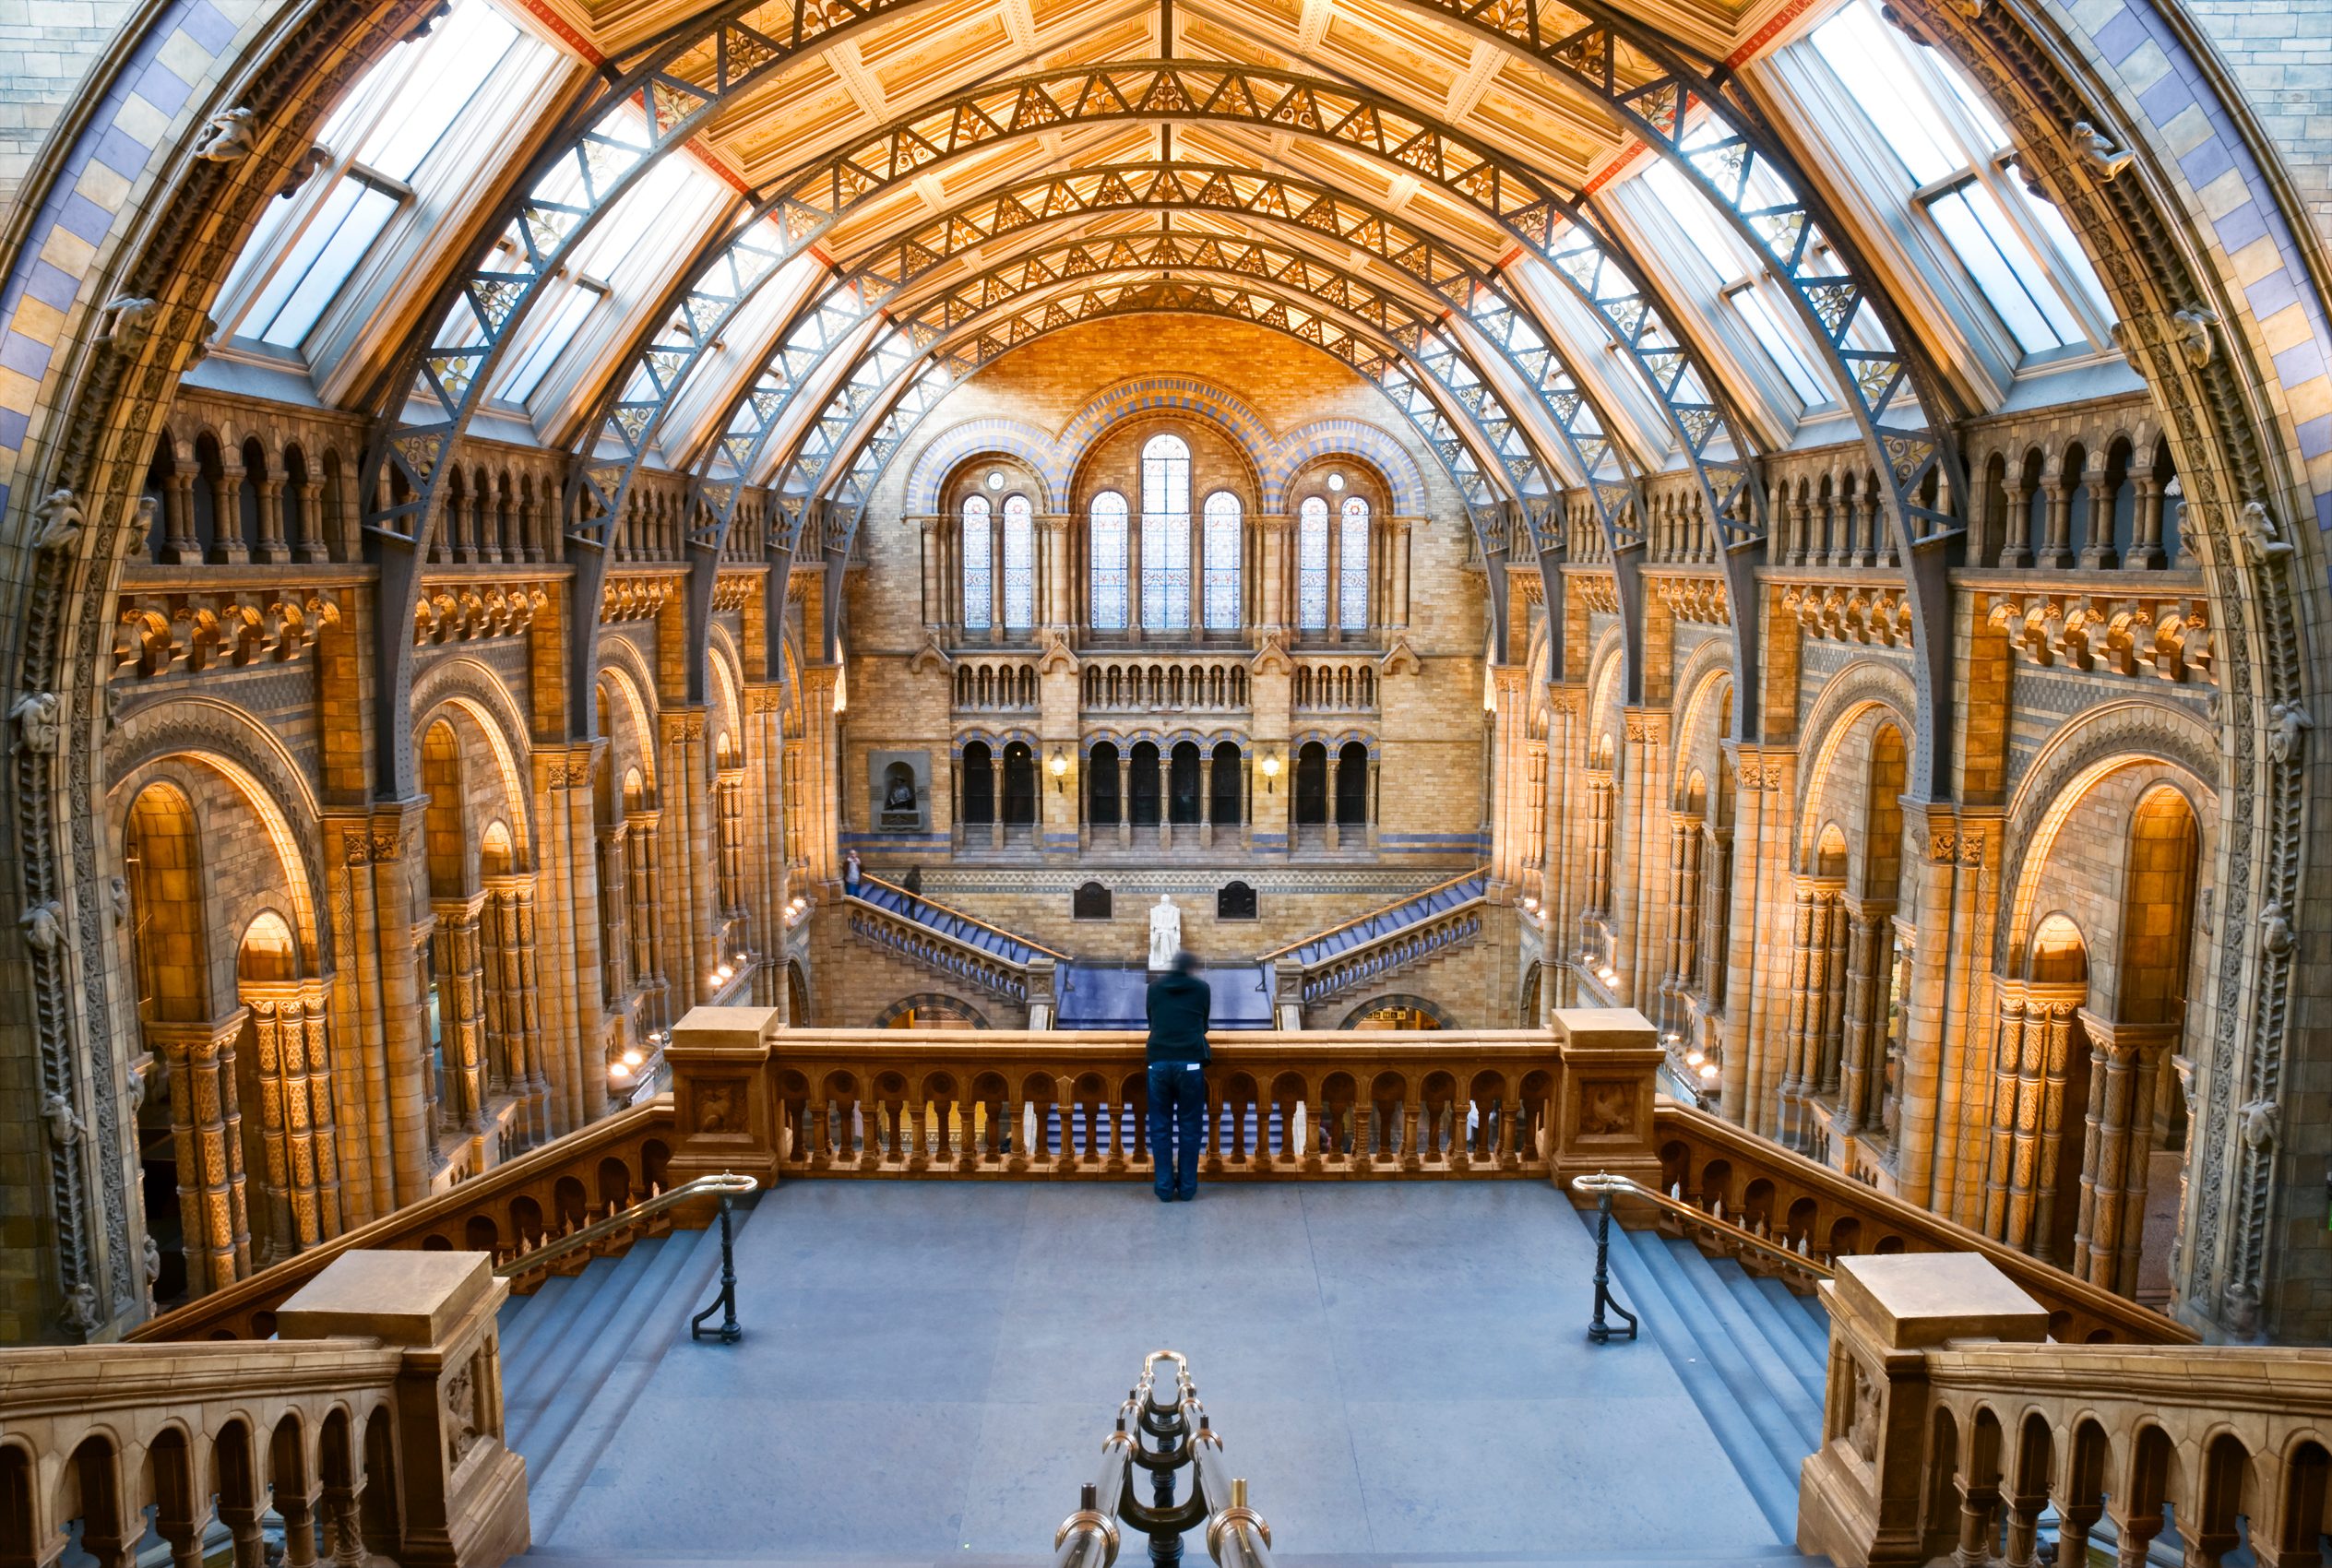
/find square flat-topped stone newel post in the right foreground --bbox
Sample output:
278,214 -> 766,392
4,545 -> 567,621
1798,1253 -> 2048,1568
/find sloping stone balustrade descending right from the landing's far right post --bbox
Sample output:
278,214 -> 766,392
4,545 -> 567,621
1656,1099 -> 2196,1344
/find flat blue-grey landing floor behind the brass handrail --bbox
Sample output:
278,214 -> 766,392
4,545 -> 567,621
513,1181 -> 1784,1563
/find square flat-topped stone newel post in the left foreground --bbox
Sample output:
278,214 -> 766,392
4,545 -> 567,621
275,1251 -> 531,1568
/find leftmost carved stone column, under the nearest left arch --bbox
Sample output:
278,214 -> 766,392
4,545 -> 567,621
145,1008 -> 252,1295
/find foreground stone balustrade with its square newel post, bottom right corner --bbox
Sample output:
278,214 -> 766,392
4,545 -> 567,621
1798,1253 -> 2332,1568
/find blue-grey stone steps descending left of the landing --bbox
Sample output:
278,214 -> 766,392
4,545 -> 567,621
502,1199 -> 751,1540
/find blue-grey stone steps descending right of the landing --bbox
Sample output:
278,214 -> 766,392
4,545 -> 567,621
1581,1208 -> 1830,1540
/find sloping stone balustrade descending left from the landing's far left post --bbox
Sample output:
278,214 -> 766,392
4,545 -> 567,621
133,1097 -> 681,1344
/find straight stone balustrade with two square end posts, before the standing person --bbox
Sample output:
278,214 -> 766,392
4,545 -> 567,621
664,1008 -> 1660,1181
